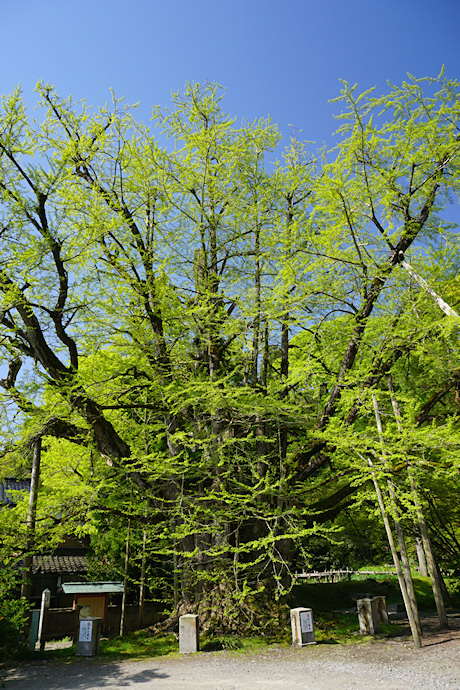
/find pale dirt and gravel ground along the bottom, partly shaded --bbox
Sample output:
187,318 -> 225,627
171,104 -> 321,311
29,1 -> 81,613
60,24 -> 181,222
5,614 -> 460,690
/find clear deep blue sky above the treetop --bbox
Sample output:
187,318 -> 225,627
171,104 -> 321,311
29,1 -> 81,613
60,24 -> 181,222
0,0 -> 460,144
